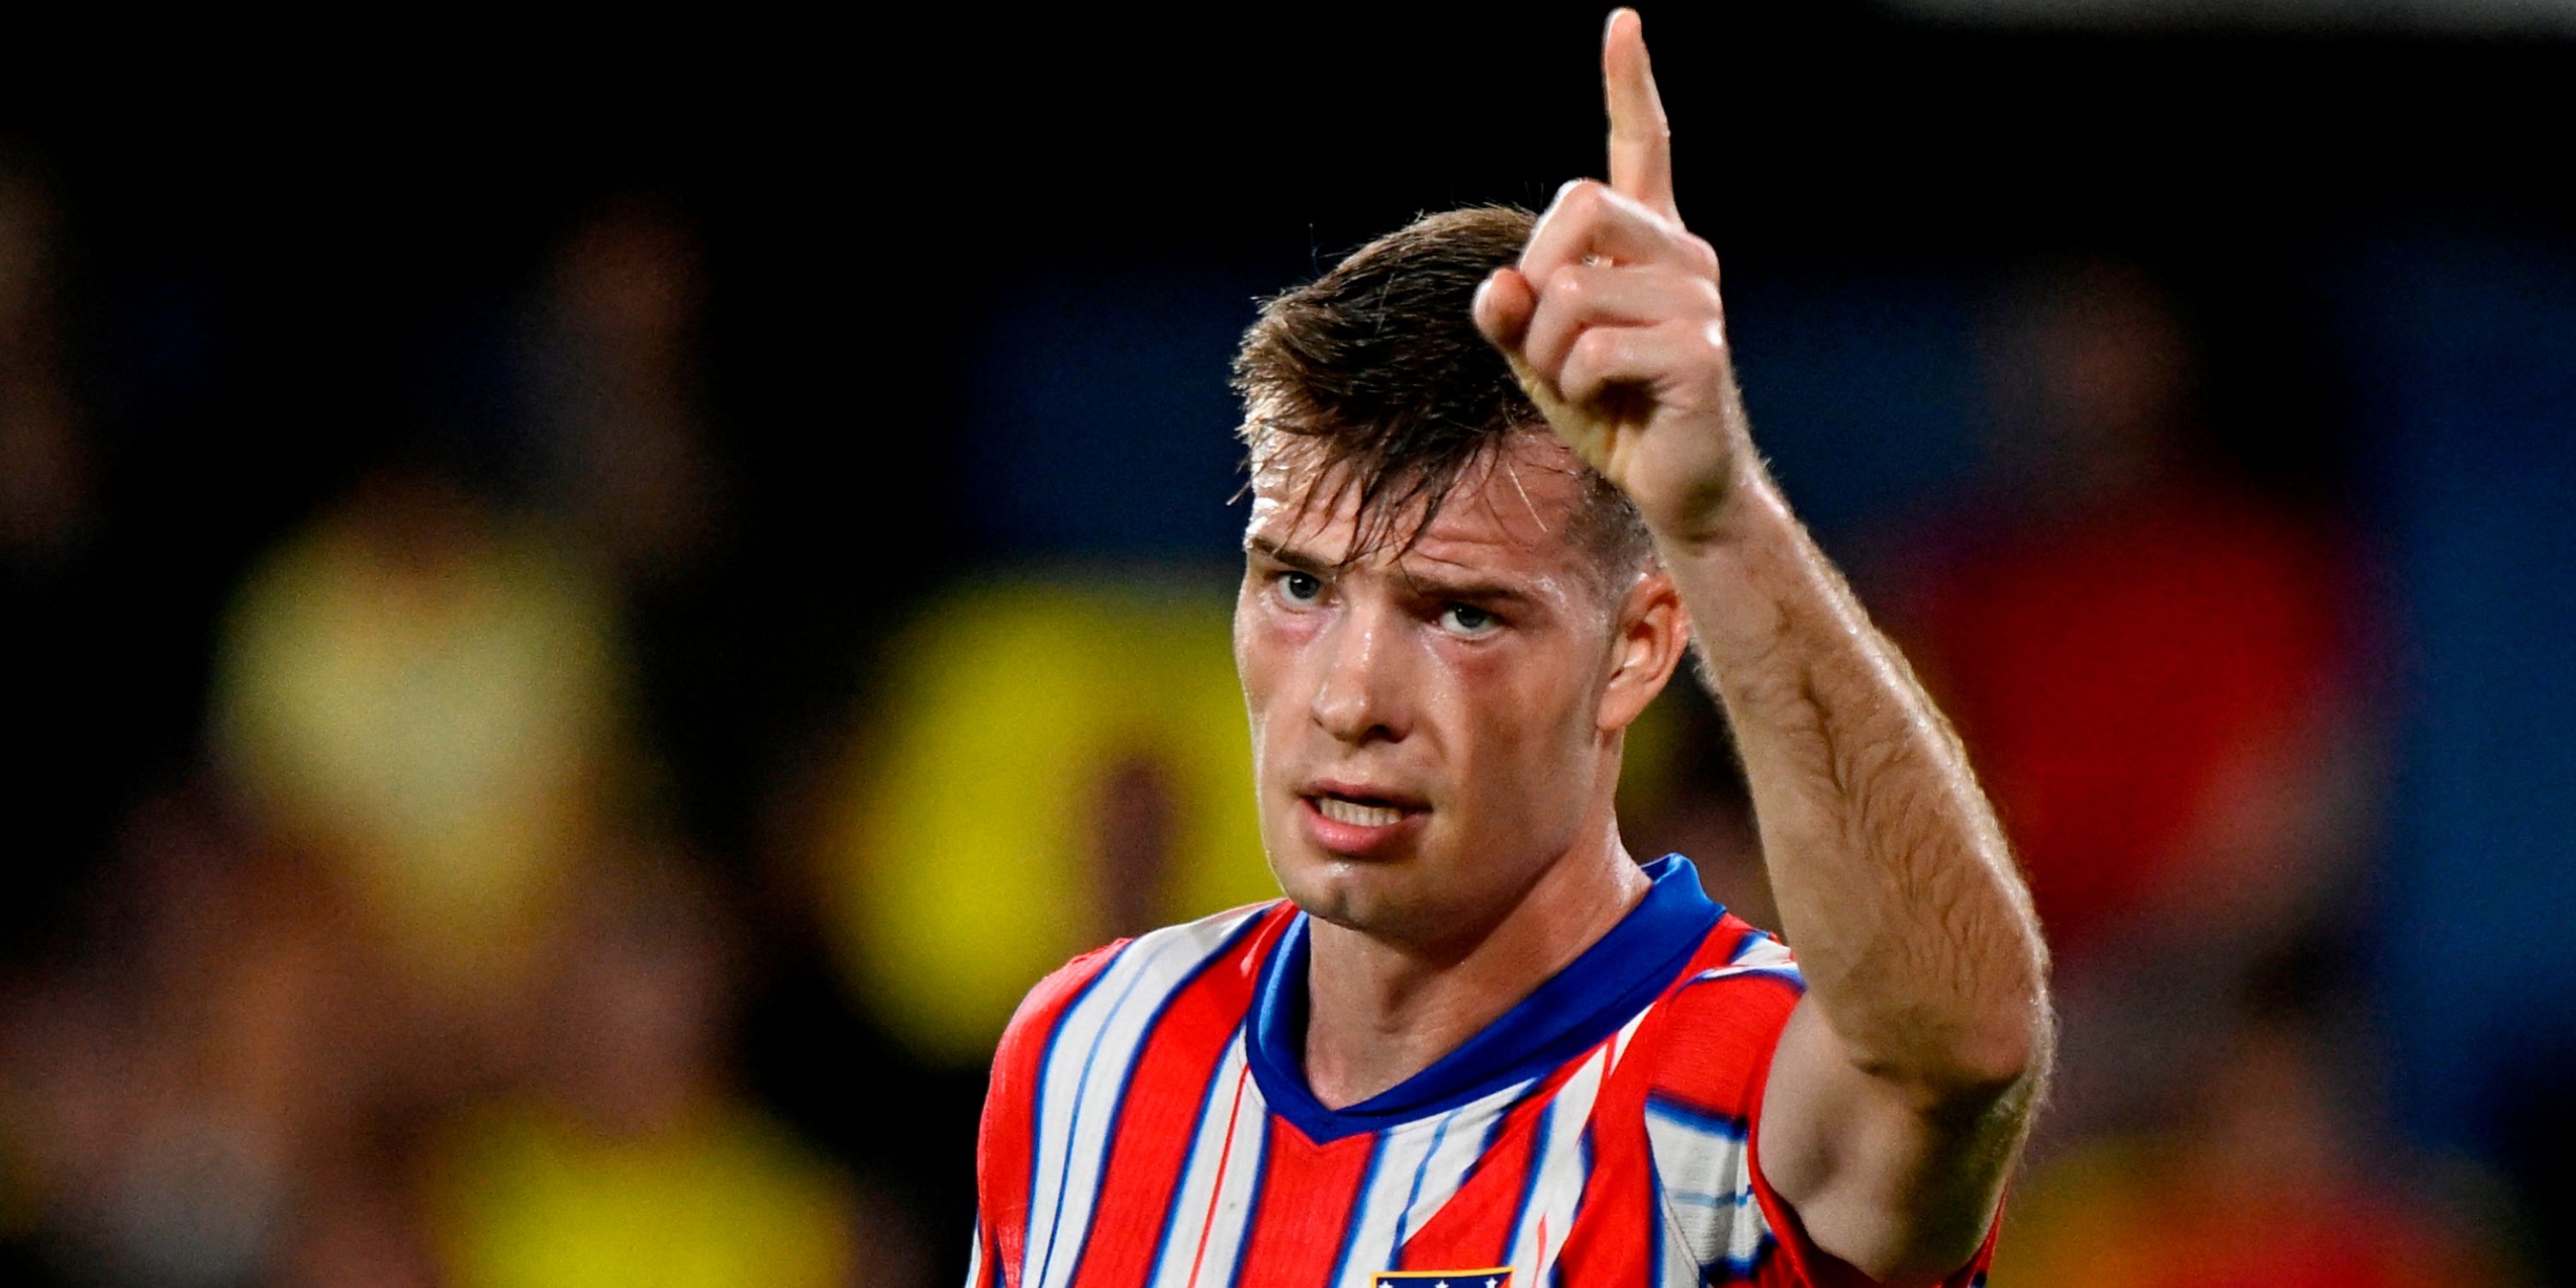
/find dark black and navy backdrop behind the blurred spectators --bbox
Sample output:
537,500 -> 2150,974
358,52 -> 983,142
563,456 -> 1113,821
0,3 -> 2576,1283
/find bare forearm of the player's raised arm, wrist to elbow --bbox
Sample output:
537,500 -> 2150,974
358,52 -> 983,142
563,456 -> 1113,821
1659,466 -> 2048,1097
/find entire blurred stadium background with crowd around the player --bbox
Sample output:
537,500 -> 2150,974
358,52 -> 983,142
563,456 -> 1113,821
0,0 -> 2576,1288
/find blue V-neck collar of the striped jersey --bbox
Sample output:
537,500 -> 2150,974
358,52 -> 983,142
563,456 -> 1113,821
1244,855 -> 1726,1144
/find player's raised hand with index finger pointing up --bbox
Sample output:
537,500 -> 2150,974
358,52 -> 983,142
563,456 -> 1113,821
1476,8 -> 1759,544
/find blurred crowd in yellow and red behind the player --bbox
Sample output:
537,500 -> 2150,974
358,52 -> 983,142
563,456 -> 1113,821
0,106 -> 2576,1288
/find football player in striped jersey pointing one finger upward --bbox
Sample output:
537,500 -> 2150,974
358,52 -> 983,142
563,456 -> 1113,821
971,10 -> 2050,1288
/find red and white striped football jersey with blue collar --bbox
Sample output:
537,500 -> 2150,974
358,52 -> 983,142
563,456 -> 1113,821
969,855 -> 1994,1288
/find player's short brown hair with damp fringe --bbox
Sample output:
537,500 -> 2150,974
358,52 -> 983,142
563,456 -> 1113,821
1234,206 -> 1654,577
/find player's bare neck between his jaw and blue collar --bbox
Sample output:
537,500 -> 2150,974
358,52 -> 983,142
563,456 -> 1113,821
1306,819 -> 1649,1110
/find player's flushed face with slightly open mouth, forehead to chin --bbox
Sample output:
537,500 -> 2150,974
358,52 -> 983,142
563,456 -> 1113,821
1234,435 -> 1625,945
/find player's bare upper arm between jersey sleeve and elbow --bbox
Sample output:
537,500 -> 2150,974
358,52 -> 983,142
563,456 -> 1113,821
1752,999 -> 2035,1283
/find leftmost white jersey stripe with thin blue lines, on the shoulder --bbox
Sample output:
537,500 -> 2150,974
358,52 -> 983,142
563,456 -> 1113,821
1020,907 -> 1262,1288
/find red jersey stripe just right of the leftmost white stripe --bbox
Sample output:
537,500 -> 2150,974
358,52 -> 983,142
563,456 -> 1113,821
1074,904 -> 1296,1288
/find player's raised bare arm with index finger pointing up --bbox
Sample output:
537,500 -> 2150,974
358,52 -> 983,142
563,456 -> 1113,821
1476,10 -> 2053,1283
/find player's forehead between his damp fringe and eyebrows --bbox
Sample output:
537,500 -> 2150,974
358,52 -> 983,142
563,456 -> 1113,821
1247,430 -> 1587,572
